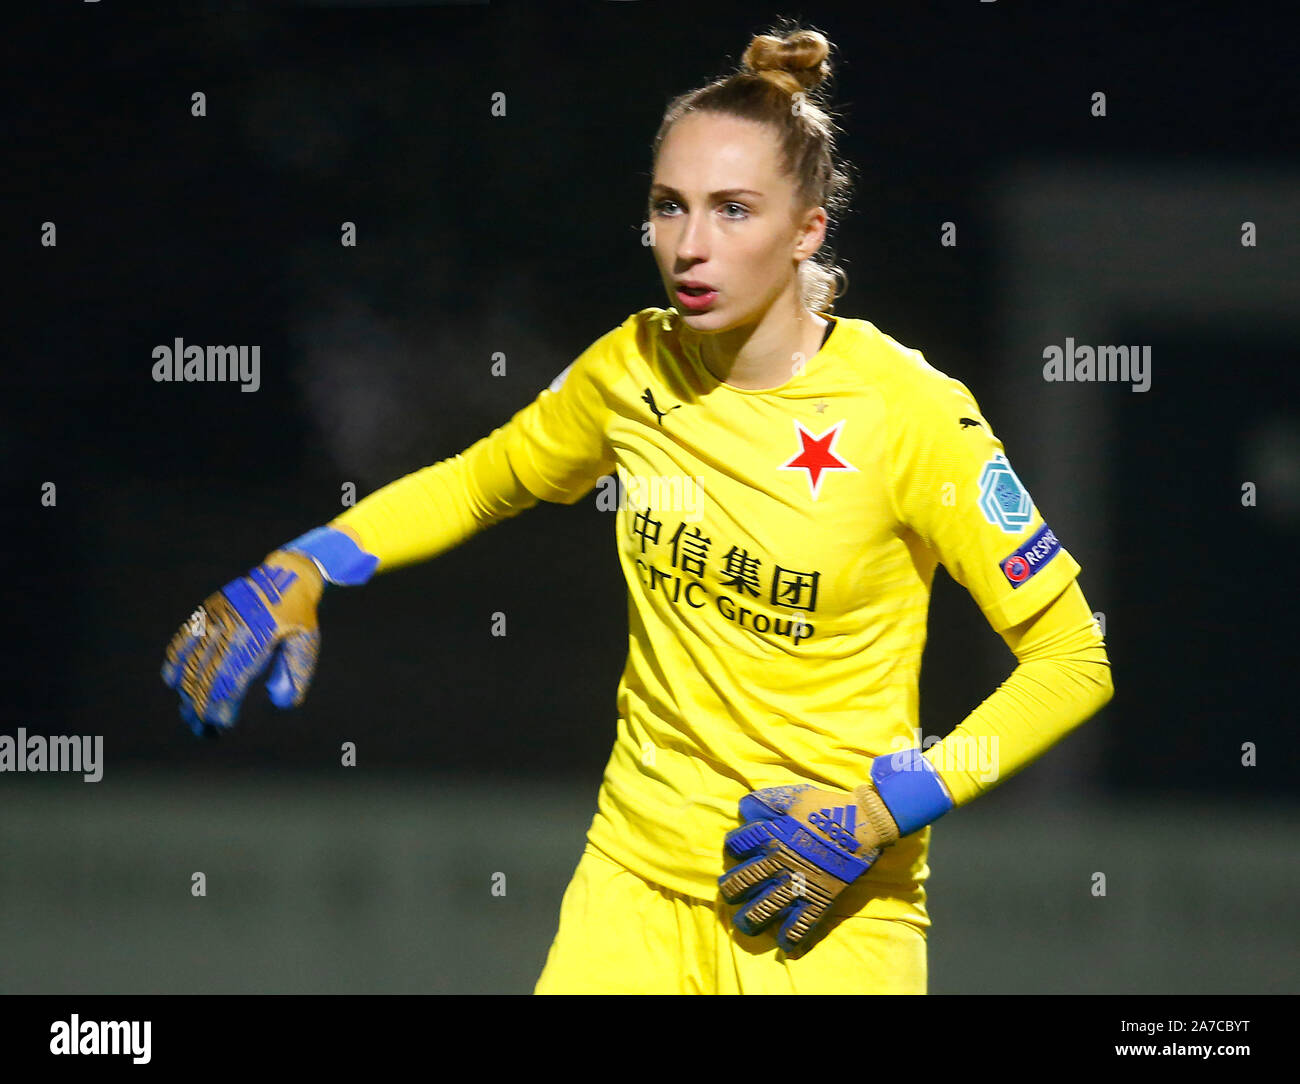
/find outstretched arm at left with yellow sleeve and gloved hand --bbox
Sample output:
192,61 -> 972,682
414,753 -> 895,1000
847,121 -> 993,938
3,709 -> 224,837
163,317 -> 631,736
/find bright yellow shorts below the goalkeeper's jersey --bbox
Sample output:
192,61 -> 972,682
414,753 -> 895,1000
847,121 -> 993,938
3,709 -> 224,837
533,842 -> 927,994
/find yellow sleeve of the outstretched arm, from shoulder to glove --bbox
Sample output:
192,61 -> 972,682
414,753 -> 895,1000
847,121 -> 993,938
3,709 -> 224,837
329,316 -> 624,572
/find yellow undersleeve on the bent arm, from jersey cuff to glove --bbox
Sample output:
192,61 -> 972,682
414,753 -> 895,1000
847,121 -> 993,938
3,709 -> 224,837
923,580 -> 1114,806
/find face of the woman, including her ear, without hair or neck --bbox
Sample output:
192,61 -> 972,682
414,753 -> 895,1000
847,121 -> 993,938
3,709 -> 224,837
650,113 -> 826,331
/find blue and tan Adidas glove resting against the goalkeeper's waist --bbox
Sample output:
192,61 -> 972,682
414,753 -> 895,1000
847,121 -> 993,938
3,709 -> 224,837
718,749 -> 953,953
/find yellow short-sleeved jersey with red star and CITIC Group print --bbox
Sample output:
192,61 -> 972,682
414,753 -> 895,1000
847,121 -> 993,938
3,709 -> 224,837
335,301 -> 1079,927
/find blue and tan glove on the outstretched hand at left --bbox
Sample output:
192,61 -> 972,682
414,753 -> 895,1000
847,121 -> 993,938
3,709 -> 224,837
163,526 -> 378,737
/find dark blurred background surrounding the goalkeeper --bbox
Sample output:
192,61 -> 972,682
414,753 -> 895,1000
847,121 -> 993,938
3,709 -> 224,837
0,3 -> 1300,992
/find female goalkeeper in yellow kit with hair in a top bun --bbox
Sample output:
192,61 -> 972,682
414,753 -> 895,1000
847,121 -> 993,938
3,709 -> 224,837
164,30 -> 1113,993
